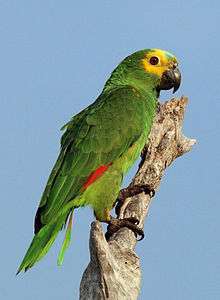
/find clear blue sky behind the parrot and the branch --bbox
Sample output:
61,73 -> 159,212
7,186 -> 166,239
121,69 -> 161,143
0,0 -> 220,300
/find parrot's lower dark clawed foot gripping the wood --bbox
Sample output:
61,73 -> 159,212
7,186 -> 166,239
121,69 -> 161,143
105,217 -> 144,241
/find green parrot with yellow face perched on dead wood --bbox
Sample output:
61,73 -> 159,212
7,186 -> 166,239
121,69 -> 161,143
17,49 -> 181,273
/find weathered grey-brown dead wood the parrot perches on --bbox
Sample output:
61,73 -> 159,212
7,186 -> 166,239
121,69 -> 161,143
80,97 -> 196,300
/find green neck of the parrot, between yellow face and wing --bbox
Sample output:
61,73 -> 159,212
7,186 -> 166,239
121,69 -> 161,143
103,66 -> 158,99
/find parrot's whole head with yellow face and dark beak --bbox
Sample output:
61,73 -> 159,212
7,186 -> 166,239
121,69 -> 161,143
105,49 -> 181,95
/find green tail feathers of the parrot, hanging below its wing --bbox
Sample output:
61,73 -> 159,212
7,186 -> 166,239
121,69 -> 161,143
17,209 -> 73,274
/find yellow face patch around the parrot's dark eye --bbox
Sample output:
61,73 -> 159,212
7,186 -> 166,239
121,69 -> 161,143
141,49 -> 178,78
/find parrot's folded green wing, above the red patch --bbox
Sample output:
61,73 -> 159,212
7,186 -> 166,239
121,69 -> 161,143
35,87 -> 147,232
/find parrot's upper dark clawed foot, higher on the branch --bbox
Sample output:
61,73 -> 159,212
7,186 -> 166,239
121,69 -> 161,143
115,185 -> 155,216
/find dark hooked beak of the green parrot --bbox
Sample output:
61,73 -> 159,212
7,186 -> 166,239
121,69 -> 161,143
158,67 -> 181,93
